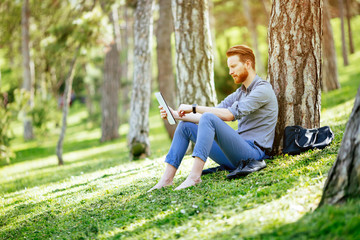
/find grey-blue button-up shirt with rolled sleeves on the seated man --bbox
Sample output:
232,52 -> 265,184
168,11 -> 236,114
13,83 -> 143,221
216,75 -> 278,150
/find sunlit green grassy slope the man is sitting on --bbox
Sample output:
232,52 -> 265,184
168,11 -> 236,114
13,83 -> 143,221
0,19 -> 360,239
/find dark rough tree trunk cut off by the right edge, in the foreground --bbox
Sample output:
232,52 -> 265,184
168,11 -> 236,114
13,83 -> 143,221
319,88 -> 360,206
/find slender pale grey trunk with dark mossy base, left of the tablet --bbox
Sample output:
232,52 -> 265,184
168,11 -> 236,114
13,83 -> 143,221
128,0 -> 153,159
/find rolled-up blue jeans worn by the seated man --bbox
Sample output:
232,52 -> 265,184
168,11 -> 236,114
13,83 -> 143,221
165,113 -> 265,170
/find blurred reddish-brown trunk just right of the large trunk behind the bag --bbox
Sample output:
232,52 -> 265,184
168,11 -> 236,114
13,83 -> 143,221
321,0 -> 340,92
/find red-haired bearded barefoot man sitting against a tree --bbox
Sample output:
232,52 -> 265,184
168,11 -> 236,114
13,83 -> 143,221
149,45 -> 278,191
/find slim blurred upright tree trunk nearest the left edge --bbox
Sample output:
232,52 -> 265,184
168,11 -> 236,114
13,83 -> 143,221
21,0 -> 34,140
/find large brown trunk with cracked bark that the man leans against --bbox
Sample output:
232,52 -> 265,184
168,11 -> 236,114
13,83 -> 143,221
268,0 -> 323,154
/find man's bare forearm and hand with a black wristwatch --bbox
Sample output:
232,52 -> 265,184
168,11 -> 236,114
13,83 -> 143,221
177,104 -> 234,121
